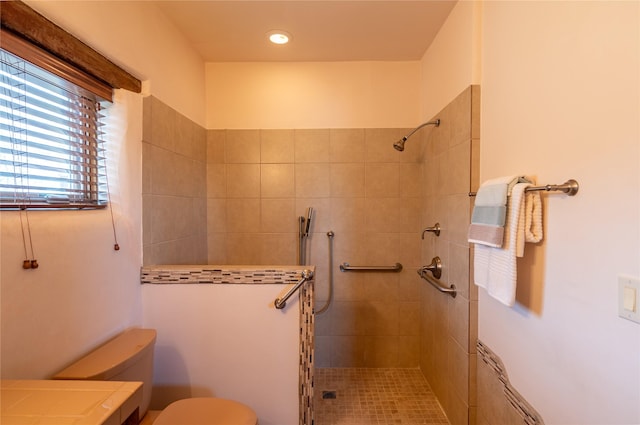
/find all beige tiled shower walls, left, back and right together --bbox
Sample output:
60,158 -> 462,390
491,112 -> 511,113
143,87 -> 479,425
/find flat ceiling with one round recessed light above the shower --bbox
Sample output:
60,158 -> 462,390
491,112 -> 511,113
155,0 -> 457,62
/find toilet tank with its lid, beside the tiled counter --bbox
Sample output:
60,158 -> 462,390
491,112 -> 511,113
53,328 -> 156,417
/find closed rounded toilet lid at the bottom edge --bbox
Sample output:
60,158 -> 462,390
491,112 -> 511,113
153,397 -> 258,425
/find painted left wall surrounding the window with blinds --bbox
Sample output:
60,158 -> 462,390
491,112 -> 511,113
0,1 -> 205,378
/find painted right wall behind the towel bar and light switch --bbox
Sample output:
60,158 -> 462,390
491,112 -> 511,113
479,1 -> 640,424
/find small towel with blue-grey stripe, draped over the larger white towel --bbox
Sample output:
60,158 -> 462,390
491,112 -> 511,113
468,176 -> 528,248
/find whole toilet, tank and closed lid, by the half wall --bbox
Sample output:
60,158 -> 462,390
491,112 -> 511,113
53,328 -> 258,425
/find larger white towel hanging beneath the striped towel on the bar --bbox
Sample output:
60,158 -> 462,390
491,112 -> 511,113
474,183 -> 542,306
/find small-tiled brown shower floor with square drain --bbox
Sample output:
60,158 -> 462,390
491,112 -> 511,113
314,368 -> 449,425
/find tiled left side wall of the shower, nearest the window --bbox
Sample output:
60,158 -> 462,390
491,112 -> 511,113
142,96 -> 207,265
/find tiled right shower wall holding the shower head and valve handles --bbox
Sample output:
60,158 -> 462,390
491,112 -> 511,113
420,86 -> 480,425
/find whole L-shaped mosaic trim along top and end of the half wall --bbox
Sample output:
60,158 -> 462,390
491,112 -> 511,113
140,265 -> 315,425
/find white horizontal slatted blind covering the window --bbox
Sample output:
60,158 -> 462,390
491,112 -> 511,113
0,50 -> 107,208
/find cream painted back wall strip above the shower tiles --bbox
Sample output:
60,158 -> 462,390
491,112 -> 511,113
206,61 -> 420,129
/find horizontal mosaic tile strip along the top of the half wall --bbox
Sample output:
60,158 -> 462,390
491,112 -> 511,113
140,266 -> 302,284
